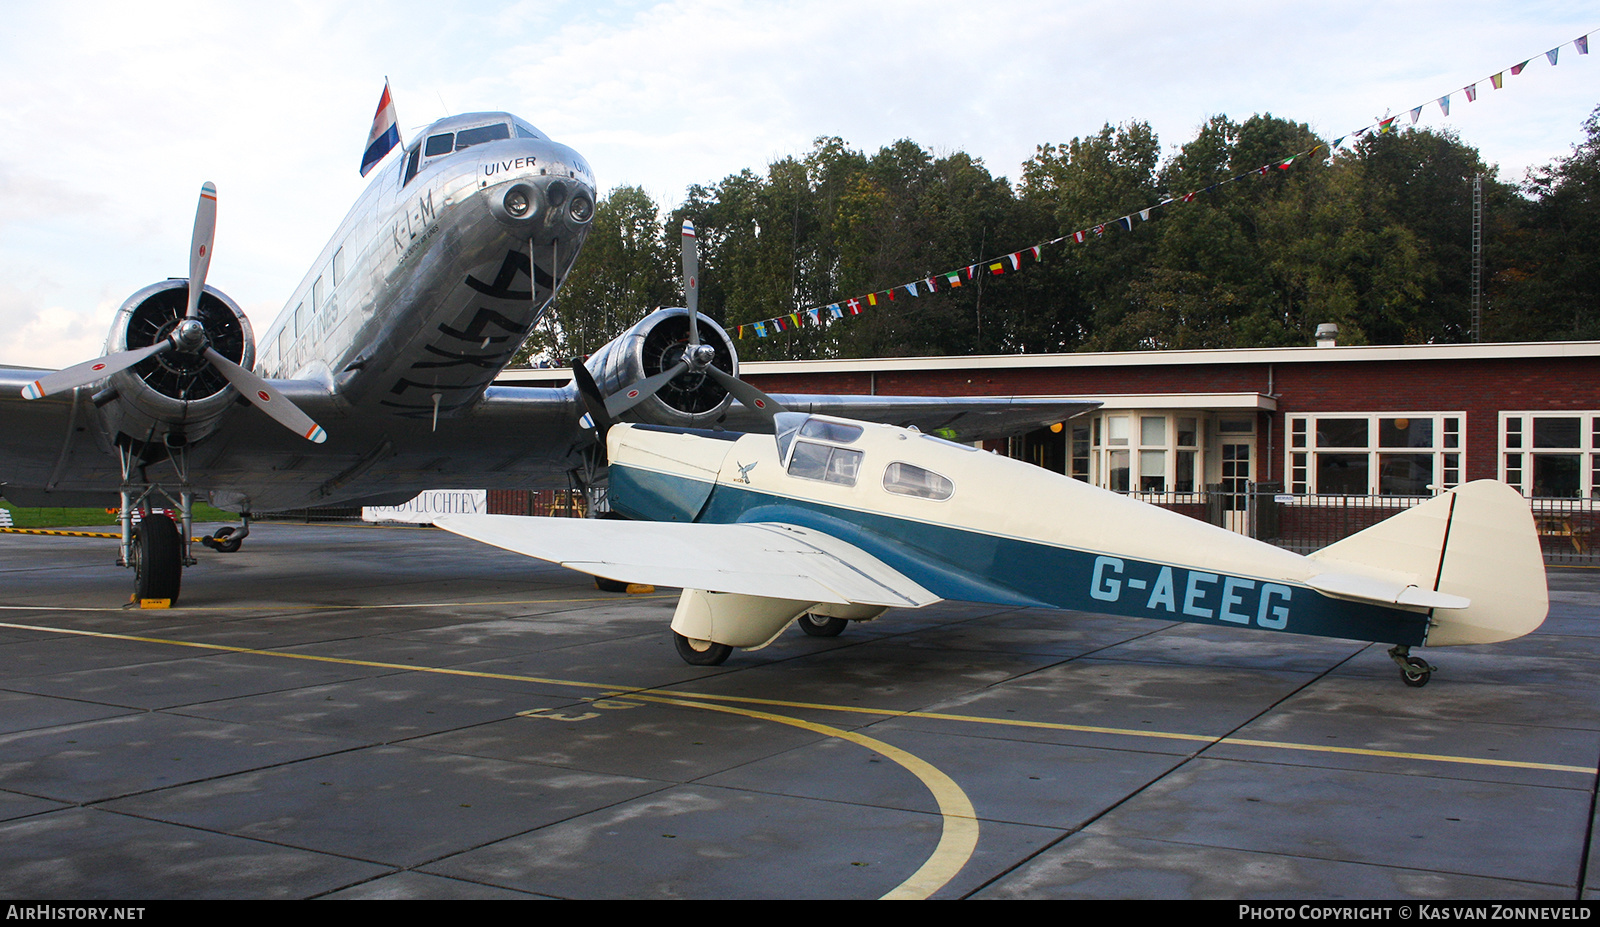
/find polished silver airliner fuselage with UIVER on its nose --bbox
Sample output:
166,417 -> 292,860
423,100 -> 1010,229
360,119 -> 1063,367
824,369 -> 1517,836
256,112 -> 595,416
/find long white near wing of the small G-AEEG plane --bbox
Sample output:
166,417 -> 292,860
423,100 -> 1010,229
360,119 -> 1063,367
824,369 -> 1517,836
434,516 -> 939,608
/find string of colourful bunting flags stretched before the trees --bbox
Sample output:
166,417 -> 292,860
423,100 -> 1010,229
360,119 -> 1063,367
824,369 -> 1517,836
734,34 -> 1592,339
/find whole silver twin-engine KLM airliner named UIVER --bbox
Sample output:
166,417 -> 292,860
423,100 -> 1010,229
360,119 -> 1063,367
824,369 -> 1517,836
0,112 -> 1086,600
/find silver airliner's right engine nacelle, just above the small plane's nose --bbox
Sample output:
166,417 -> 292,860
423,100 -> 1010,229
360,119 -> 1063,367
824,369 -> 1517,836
586,307 -> 739,427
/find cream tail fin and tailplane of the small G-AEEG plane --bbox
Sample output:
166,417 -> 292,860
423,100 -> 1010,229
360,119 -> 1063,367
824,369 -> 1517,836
1310,480 -> 1550,647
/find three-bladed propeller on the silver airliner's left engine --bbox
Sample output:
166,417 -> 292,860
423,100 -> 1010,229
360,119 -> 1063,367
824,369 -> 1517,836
22,181 -> 328,443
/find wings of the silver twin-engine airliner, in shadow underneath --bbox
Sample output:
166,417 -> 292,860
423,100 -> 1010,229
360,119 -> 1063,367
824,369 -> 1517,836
0,358 -> 1094,512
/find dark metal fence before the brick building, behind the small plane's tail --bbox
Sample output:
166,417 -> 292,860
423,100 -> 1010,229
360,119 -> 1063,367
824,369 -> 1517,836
1130,484 -> 1600,565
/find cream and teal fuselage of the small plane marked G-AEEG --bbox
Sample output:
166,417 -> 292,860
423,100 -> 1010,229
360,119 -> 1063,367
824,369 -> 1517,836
610,416 -> 1429,645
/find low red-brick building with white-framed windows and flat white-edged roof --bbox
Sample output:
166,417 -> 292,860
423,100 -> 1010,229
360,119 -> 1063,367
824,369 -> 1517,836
726,341 -> 1600,500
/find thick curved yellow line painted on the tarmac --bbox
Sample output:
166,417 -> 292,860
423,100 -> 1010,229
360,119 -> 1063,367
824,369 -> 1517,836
627,692 -> 978,901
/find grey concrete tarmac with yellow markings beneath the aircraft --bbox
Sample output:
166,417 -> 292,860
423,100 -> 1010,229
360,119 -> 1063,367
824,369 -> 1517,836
0,524 -> 1600,901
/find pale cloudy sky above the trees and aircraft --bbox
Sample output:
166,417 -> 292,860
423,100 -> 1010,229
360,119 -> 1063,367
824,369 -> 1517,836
0,0 -> 1600,368
